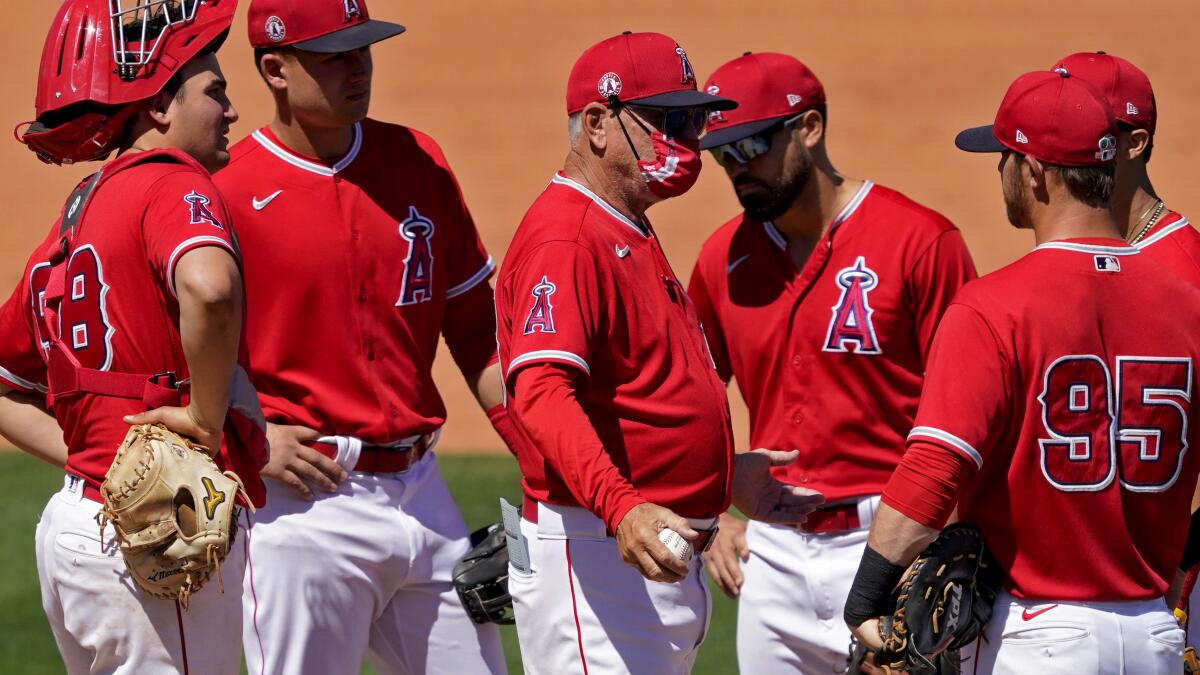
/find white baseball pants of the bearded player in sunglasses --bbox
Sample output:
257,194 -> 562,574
738,497 -> 878,675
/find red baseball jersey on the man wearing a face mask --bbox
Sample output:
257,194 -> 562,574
496,174 -> 733,518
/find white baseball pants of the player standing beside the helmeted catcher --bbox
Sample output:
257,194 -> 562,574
244,453 -> 505,675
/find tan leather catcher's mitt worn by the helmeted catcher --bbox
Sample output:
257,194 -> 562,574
96,424 -> 250,608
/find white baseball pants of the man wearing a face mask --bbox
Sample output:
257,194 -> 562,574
509,504 -> 712,675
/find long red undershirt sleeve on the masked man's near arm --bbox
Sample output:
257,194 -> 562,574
509,363 -> 646,532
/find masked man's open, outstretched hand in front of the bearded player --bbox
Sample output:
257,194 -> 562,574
733,448 -> 824,525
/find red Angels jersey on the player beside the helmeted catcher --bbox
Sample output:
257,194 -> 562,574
216,119 -> 494,443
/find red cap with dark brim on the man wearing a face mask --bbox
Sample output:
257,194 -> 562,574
566,30 -> 738,115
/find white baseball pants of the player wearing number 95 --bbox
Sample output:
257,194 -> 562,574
960,592 -> 1183,675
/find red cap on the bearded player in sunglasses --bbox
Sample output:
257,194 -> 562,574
700,52 -> 826,150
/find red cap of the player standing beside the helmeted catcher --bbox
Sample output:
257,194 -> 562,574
247,0 -> 404,54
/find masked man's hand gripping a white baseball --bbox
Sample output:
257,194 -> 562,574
617,502 -> 700,584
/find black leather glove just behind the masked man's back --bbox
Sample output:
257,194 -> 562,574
452,522 -> 515,623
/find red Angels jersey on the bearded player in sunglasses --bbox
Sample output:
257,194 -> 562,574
688,181 -> 976,501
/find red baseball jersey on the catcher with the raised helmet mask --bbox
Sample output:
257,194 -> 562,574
0,151 -> 246,482
